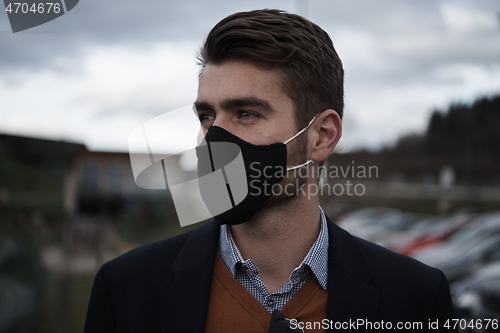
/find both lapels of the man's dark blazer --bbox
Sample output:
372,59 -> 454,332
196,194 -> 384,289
160,217 -> 379,333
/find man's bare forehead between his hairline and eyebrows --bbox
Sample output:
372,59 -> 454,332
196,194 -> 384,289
198,62 -> 293,107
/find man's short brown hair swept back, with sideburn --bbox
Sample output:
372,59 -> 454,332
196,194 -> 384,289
198,9 -> 344,128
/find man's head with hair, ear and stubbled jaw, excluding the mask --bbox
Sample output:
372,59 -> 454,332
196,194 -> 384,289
195,10 -> 343,214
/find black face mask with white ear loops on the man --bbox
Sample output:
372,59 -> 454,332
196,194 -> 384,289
196,117 -> 316,225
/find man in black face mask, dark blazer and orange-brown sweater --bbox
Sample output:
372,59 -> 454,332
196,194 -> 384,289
85,10 -> 453,333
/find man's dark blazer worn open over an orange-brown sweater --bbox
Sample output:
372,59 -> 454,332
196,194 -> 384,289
85,219 -> 455,333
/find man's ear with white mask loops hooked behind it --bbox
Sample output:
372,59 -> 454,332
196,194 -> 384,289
309,109 -> 342,162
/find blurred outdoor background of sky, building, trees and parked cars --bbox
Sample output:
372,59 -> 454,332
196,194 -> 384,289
0,0 -> 500,333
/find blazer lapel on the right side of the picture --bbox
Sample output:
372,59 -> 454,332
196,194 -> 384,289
327,219 -> 380,332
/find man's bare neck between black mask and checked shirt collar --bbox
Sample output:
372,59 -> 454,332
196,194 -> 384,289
230,191 -> 321,293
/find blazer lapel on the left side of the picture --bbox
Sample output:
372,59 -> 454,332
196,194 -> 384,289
160,220 -> 219,333
